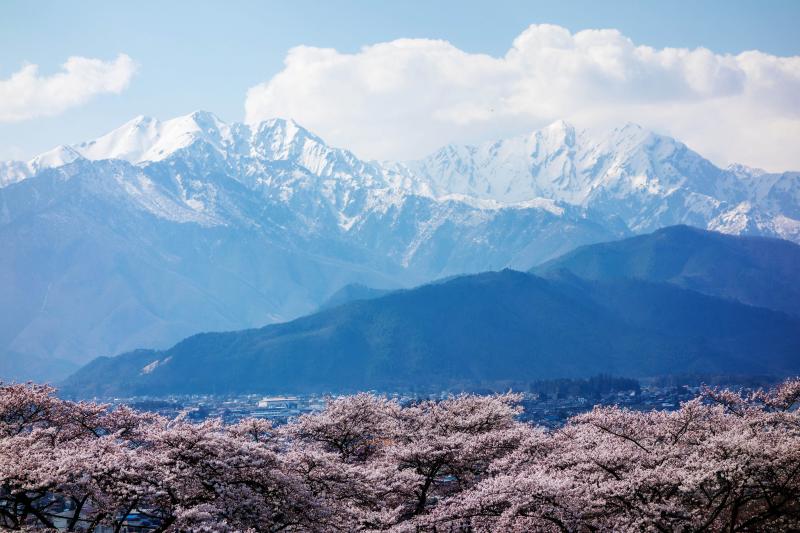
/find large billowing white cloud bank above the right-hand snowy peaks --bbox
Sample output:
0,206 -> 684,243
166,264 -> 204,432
245,25 -> 800,170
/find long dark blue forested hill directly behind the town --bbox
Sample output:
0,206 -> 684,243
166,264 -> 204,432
63,270 -> 800,396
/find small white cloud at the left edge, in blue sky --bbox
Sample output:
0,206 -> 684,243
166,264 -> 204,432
0,54 -> 136,122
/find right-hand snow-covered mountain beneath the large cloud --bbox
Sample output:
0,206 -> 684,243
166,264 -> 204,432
388,121 -> 800,240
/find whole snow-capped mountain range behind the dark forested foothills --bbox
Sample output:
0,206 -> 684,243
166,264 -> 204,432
0,112 -> 800,378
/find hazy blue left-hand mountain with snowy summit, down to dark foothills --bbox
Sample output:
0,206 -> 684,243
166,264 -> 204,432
0,113 -> 629,377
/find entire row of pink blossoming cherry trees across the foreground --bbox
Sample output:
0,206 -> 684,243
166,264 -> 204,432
0,379 -> 800,532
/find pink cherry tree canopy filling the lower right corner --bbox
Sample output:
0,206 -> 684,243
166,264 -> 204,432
427,380 -> 800,531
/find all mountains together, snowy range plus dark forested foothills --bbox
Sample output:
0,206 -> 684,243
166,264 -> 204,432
0,112 -> 800,386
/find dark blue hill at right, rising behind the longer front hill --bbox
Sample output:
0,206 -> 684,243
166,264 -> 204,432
531,226 -> 800,316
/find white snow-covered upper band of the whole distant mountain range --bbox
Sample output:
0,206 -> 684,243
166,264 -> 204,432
0,111 -> 800,245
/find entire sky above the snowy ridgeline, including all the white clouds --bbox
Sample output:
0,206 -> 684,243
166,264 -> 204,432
0,0 -> 800,171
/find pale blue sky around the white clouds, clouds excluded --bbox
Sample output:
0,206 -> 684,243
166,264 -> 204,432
0,1 -> 800,164
